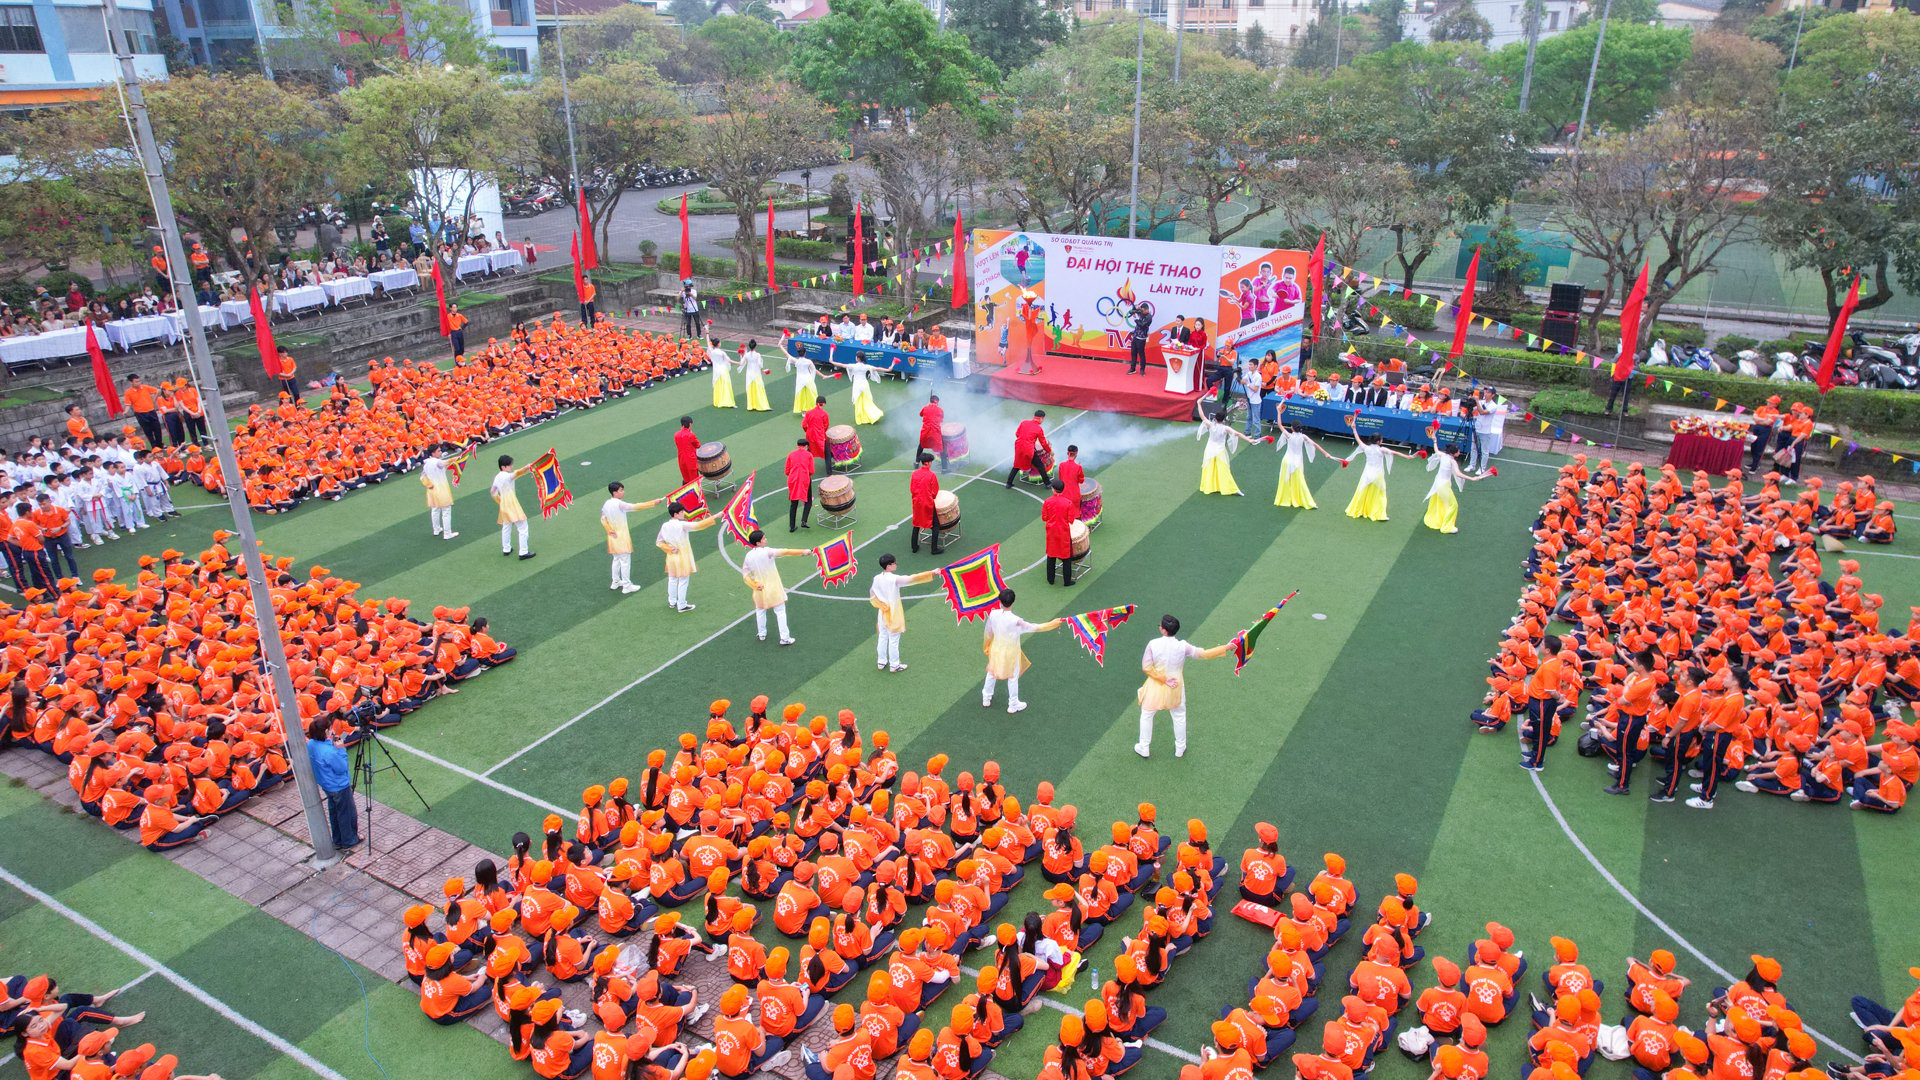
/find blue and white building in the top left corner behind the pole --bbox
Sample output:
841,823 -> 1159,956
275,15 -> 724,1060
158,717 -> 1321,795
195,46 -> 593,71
0,0 -> 167,110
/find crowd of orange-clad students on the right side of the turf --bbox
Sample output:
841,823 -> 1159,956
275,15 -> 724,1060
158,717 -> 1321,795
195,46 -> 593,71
1473,455 -> 1920,813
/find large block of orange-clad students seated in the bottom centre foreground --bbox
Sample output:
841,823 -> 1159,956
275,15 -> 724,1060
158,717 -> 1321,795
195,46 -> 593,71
401,698 -> 1225,1080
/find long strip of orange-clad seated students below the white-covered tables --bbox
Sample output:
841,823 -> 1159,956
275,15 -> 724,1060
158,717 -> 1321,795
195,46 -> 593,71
161,317 -> 705,513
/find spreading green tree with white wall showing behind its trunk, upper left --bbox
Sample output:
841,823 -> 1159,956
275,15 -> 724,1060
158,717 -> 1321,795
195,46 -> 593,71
340,65 -> 534,294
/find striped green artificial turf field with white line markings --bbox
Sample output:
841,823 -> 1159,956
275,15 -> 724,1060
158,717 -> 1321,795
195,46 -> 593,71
0,363 -> 1920,1080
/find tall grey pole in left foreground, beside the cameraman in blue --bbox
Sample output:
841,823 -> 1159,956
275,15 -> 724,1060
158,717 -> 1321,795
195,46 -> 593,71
104,0 -> 340,869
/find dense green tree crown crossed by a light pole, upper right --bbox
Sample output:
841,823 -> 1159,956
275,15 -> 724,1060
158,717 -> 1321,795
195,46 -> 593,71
1486,17 -> 1692,131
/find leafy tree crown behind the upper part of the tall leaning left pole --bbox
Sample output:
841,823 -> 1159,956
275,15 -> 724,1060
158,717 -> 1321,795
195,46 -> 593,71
6,73 -> 336,294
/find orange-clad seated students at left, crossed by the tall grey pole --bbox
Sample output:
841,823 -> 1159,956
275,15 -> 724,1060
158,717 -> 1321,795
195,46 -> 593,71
0,532 -> 515,851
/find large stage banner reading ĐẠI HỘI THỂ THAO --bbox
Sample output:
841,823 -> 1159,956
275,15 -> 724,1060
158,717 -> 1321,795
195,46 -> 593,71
973,229 -> 1308,392
